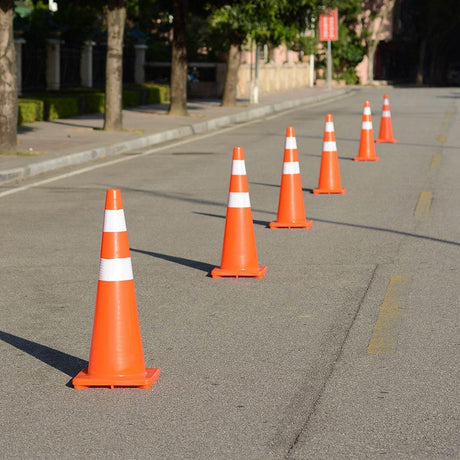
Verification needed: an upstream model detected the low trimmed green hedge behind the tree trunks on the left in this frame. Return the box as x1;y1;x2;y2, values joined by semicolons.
18;83;169;124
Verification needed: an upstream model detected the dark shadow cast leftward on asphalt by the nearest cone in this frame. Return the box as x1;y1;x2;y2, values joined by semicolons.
0;331;88;387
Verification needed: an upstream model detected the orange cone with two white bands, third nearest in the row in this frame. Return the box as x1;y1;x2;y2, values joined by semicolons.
269;126;313;228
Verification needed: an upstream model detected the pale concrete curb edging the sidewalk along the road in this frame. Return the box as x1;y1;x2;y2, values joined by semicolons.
0;89;354;184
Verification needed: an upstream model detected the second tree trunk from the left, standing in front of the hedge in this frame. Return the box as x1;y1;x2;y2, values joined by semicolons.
104;0;126;131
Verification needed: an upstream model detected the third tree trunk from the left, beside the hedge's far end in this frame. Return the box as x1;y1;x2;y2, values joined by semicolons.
169;0;188;116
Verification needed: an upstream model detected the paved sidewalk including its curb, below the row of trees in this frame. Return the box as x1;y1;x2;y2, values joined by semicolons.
0;88;353;184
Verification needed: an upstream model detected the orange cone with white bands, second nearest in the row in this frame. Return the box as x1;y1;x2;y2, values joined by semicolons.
211;147;267;278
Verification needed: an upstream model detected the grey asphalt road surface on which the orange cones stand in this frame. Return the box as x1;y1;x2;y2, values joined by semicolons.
0;88;460;459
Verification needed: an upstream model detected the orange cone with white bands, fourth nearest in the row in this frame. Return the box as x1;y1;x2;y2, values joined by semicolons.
313;113;345;195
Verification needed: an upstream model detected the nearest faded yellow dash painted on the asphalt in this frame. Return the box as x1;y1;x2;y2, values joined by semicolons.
367;276;412;354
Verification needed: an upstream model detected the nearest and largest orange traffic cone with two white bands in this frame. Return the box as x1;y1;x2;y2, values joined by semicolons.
72;189;160;389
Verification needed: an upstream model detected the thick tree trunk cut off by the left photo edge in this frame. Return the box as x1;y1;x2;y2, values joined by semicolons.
0;0;18;153
